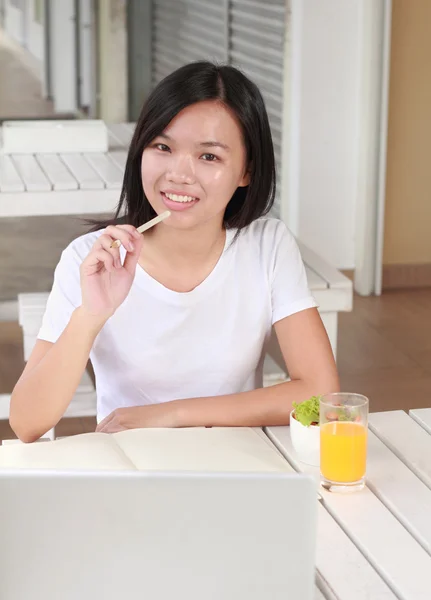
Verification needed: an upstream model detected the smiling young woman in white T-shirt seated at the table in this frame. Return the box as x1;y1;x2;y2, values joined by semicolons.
10;62;338;442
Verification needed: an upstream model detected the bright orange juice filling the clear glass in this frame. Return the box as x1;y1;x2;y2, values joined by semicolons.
320;421;367;483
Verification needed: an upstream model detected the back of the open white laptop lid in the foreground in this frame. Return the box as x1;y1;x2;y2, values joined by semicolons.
0;432;317;600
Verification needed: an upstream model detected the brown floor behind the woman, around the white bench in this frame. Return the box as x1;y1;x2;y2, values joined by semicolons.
0;289;431;439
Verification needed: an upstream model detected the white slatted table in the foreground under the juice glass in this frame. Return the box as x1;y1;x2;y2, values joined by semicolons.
267;408;431;600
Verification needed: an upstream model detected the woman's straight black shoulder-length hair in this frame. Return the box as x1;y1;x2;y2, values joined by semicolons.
93;61;275;229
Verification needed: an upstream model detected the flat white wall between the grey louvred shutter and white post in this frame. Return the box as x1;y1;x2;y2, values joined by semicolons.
283;0;362;269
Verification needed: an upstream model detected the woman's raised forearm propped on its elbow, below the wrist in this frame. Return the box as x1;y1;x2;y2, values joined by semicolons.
9;308;103;442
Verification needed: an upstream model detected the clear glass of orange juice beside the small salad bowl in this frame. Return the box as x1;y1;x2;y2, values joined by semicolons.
320;392;369;492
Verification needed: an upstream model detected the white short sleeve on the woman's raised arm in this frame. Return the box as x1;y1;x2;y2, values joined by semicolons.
37;243;82;343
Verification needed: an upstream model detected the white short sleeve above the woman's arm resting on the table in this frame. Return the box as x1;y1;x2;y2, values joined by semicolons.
271;221;317;324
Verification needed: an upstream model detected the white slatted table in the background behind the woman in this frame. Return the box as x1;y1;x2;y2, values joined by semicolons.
0;123;135;218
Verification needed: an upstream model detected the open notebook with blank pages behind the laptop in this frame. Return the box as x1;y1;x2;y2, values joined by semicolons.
0;427;289;473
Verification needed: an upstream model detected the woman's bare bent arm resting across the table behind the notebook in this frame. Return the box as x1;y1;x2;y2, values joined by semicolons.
97;308;339;433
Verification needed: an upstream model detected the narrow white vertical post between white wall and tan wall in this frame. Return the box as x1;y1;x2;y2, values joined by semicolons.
355;0;392;296
